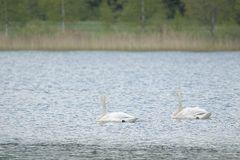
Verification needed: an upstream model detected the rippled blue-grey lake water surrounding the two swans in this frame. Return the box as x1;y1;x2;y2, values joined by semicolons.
0;52;240;159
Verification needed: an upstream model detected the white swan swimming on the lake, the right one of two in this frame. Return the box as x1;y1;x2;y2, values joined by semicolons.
171;92;211;119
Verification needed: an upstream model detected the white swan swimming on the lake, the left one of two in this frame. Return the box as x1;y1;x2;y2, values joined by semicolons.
97;96;137;123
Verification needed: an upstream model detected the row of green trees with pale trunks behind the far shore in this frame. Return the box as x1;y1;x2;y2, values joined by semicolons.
0;0;240;34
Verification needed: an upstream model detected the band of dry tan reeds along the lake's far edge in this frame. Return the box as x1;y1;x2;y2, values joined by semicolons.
0;32;240;51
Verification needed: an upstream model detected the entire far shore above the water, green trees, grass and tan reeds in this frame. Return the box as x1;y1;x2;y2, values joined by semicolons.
0;0;240;50
